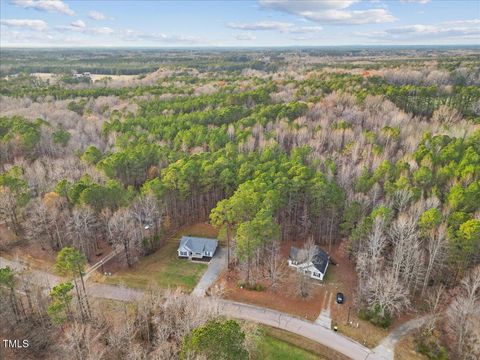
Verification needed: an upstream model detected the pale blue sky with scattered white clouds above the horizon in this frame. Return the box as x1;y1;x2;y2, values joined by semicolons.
0;0;480;47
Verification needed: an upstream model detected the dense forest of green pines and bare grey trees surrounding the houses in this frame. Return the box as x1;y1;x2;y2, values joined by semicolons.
0;49;480;359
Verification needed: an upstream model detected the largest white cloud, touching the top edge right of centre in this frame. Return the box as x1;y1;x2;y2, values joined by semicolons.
260;0;397;25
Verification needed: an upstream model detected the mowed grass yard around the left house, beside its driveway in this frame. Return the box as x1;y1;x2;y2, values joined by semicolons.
96;224;217;292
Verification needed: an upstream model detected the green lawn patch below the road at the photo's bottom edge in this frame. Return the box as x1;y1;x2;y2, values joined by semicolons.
259;335;319;360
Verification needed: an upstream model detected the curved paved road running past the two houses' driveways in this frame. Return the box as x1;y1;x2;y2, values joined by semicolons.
0;257;402;360
